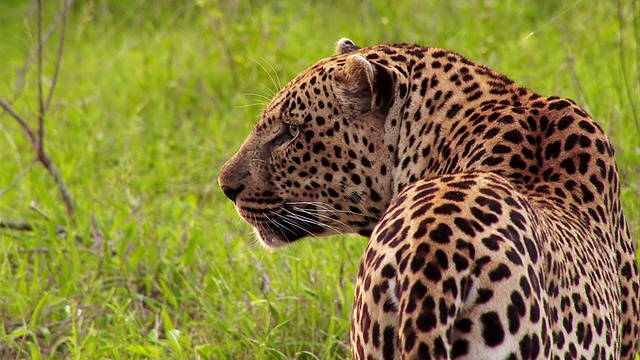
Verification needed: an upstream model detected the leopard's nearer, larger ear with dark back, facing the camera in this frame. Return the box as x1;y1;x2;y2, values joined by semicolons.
338;54;395;115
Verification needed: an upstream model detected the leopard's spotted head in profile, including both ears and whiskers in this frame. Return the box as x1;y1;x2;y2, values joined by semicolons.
218;39;397;248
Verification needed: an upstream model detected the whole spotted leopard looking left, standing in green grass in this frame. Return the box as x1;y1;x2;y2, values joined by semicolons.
218;38;640;360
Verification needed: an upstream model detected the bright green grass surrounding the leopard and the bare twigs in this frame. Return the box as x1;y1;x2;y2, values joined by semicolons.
0;0;640;359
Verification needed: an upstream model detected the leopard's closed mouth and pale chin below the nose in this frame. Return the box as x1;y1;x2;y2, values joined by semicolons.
238;203;326;248
